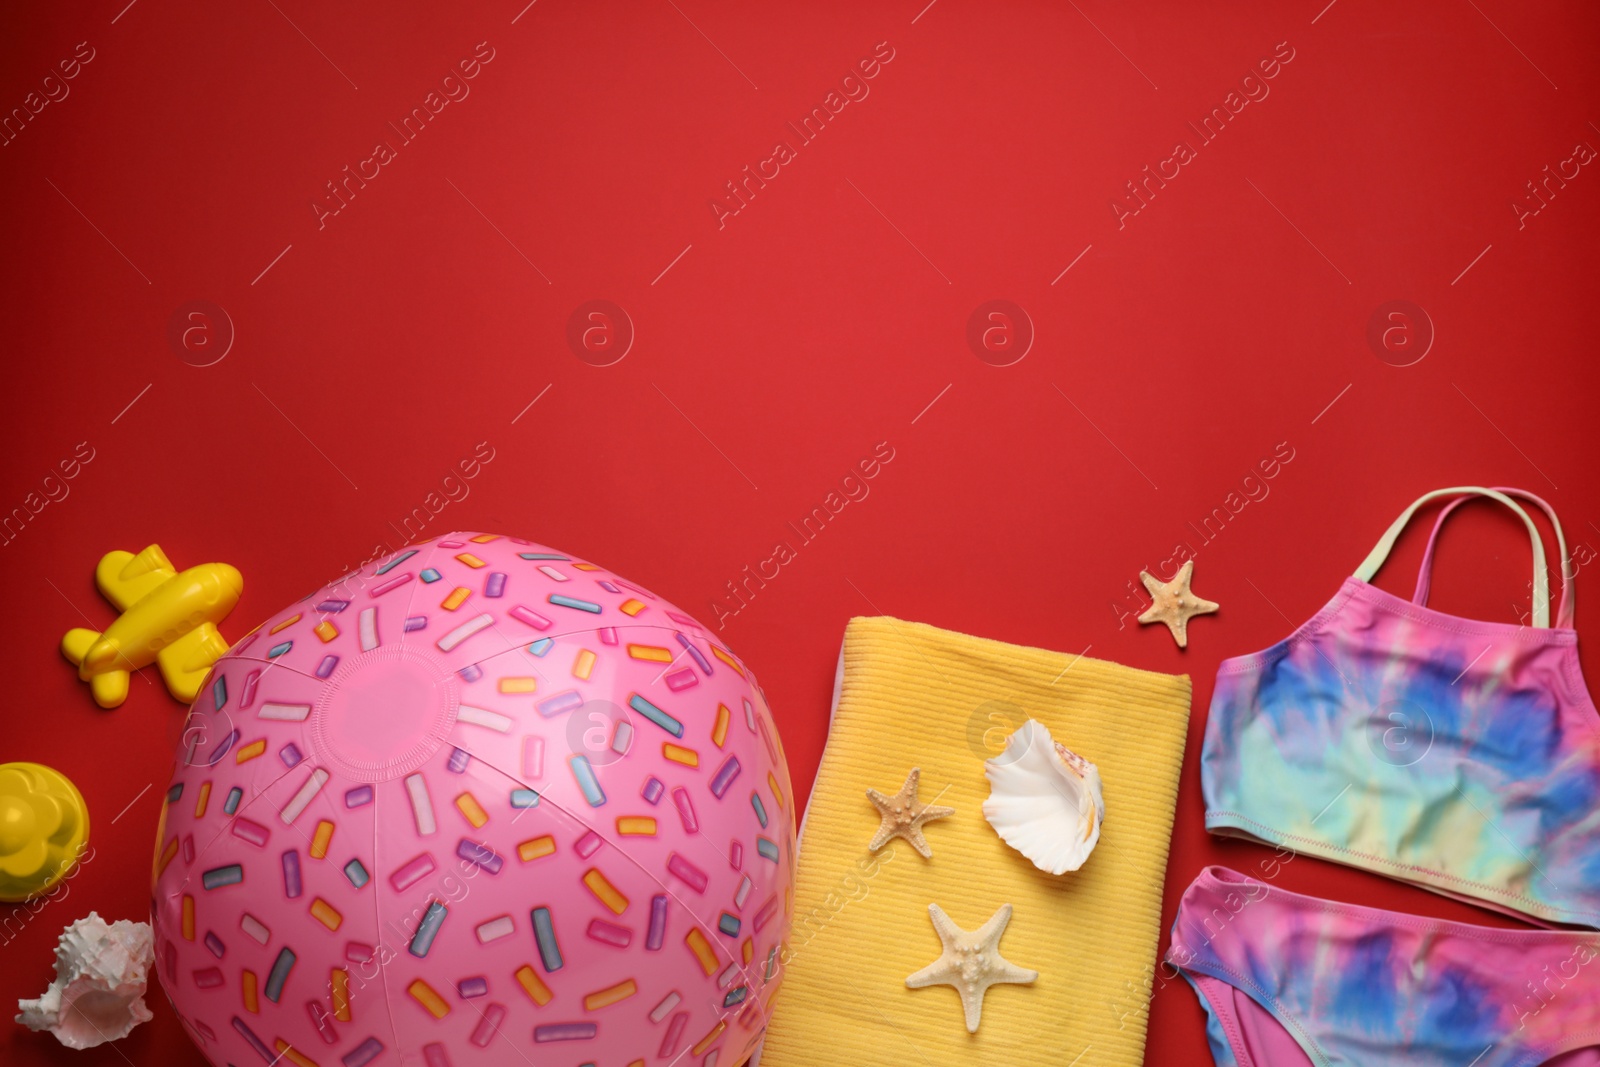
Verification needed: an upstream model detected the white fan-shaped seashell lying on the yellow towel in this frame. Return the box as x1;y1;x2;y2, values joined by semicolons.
984;718;1106;875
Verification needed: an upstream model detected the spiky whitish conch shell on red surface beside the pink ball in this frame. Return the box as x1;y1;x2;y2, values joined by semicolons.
16;912;155;1048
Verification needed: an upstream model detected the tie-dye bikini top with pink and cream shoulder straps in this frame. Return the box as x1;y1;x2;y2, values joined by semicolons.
1202;486;1600;928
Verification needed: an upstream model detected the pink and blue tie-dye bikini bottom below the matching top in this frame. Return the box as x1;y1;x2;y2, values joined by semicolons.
1166;867;1600;1067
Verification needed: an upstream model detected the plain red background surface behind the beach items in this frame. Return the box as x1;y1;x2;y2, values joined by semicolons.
0;0;1600;1064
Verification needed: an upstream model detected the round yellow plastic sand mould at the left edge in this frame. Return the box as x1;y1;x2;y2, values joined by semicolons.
0;763;90;902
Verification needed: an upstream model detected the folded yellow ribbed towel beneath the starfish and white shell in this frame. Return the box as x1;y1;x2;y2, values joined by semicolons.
762;617;1190;1067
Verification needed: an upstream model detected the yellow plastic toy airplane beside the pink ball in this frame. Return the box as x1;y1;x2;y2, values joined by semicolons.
61;544;245;707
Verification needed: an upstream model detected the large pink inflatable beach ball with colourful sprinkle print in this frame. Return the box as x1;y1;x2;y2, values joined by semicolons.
152;533;794;1067
